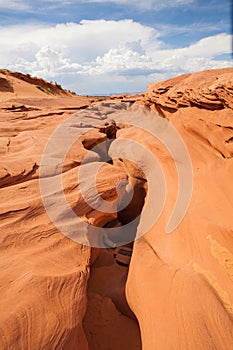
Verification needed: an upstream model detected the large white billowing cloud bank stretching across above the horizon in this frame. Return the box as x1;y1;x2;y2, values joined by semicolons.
0;20;231;94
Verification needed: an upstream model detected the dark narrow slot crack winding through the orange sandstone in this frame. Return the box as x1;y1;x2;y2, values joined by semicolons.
80;121;147;350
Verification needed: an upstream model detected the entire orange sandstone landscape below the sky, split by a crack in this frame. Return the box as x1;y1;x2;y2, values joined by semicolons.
0;69;233;350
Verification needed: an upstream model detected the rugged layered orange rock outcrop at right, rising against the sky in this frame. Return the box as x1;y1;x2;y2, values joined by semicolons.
144;68;233;112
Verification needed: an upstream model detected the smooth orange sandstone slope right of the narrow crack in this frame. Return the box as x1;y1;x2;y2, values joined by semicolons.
127;69;233;350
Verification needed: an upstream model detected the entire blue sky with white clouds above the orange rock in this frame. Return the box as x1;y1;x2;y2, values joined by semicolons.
0;0;233;95
